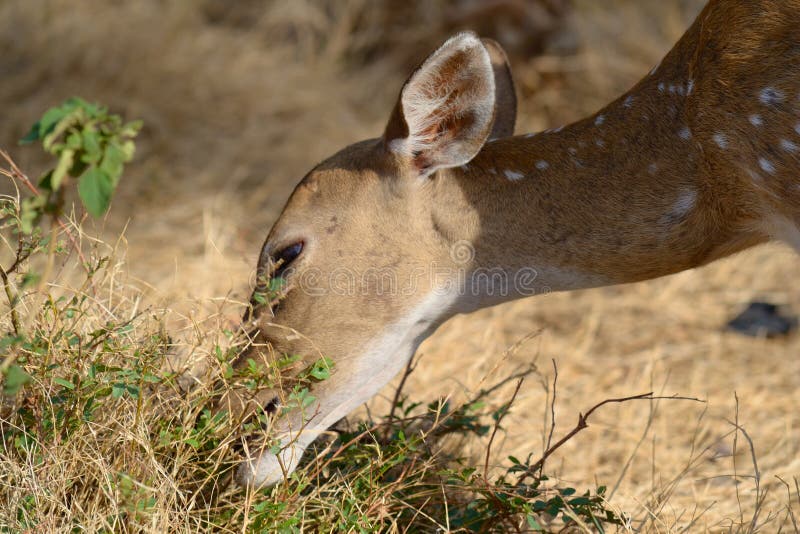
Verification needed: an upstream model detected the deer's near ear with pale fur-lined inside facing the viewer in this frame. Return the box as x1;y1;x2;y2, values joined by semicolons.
383;32;495;176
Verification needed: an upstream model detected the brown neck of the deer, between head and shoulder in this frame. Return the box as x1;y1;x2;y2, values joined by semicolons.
434;85;765;304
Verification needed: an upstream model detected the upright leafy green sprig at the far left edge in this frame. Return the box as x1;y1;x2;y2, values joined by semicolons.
0;98;141;396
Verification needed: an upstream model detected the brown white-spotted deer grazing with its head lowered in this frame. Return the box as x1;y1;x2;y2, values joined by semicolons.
226;0;800;485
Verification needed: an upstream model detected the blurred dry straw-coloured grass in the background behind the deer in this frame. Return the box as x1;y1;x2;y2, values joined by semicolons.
0;0;800;532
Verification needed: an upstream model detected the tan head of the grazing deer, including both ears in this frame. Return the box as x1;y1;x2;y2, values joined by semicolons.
227;33;516;485
